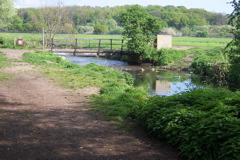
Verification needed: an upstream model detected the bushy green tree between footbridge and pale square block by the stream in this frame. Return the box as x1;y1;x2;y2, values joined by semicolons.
121;5;161;58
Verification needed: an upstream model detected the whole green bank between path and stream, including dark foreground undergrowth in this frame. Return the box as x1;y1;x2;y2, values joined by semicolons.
24;53;240;160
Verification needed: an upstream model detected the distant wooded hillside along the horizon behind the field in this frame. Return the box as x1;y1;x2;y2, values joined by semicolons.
7;5;229;37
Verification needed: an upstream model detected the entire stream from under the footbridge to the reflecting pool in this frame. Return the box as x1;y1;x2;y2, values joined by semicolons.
60;56;202;96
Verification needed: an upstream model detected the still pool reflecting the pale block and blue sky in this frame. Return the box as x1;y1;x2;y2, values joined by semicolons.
132;70;201;96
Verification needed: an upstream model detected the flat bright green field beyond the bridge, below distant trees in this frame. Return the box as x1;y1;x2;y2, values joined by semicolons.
0;33;231;48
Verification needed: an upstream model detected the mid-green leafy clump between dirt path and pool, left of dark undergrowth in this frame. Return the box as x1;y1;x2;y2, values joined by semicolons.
92;83;149;120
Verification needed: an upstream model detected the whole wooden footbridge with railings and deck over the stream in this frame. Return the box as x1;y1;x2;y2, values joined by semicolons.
50;38;127;57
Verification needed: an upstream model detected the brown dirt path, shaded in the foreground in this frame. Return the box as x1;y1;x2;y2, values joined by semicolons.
0;49;178;160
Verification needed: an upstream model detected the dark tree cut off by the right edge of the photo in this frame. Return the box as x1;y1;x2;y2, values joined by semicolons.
226;0;240;89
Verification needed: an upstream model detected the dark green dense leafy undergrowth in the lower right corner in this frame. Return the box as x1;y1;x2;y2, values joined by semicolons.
135;89;240;160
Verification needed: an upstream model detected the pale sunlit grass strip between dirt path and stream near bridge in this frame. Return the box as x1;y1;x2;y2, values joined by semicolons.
23;52;133;89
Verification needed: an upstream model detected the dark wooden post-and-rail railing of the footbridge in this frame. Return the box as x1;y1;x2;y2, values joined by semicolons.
51;38;127;52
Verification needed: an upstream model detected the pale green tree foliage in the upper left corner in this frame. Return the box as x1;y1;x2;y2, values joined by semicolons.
0;0;16;28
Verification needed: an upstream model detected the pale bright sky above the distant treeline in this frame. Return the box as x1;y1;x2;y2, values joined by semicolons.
15;0;233;14
